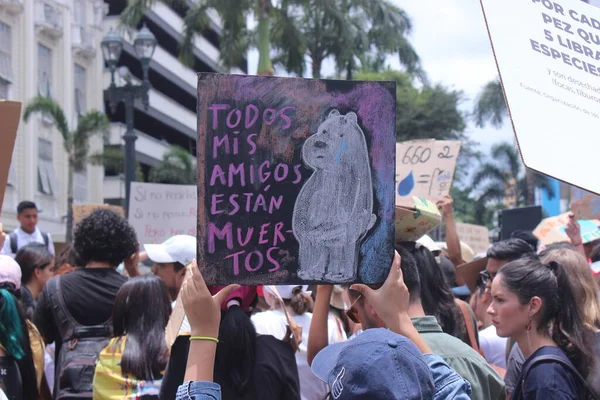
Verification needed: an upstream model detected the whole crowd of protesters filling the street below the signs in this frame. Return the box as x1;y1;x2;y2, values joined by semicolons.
0;197;600;400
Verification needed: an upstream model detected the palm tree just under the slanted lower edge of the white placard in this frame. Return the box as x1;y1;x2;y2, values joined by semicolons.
471;143;556;223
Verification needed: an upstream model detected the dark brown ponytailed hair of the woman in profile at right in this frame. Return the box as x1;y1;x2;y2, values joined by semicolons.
498;257;595;376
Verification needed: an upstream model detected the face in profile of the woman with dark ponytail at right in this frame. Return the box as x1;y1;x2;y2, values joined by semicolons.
487;274;530;338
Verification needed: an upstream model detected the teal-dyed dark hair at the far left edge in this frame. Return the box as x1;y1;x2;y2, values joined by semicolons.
0;289;25;360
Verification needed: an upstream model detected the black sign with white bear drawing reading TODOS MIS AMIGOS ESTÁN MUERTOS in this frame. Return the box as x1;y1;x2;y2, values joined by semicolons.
198;73;396;285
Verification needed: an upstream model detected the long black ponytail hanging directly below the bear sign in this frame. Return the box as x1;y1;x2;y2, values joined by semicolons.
215;305;256;399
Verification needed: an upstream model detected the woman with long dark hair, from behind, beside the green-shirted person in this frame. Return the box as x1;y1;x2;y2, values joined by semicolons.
401;242;477;347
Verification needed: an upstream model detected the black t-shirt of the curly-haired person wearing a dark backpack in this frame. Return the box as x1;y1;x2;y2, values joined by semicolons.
33;268;127;360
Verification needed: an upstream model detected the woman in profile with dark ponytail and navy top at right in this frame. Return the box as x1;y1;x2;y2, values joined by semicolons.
488;257;594;400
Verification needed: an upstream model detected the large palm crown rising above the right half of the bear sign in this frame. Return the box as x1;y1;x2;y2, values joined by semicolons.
272;0;424;79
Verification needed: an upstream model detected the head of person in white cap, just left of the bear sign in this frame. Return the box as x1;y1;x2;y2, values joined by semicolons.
144;235;196;301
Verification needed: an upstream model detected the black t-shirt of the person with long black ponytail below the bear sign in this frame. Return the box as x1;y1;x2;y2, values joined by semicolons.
160;335;300;400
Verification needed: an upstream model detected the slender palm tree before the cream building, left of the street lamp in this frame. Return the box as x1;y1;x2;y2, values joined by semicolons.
23;97;110;243
